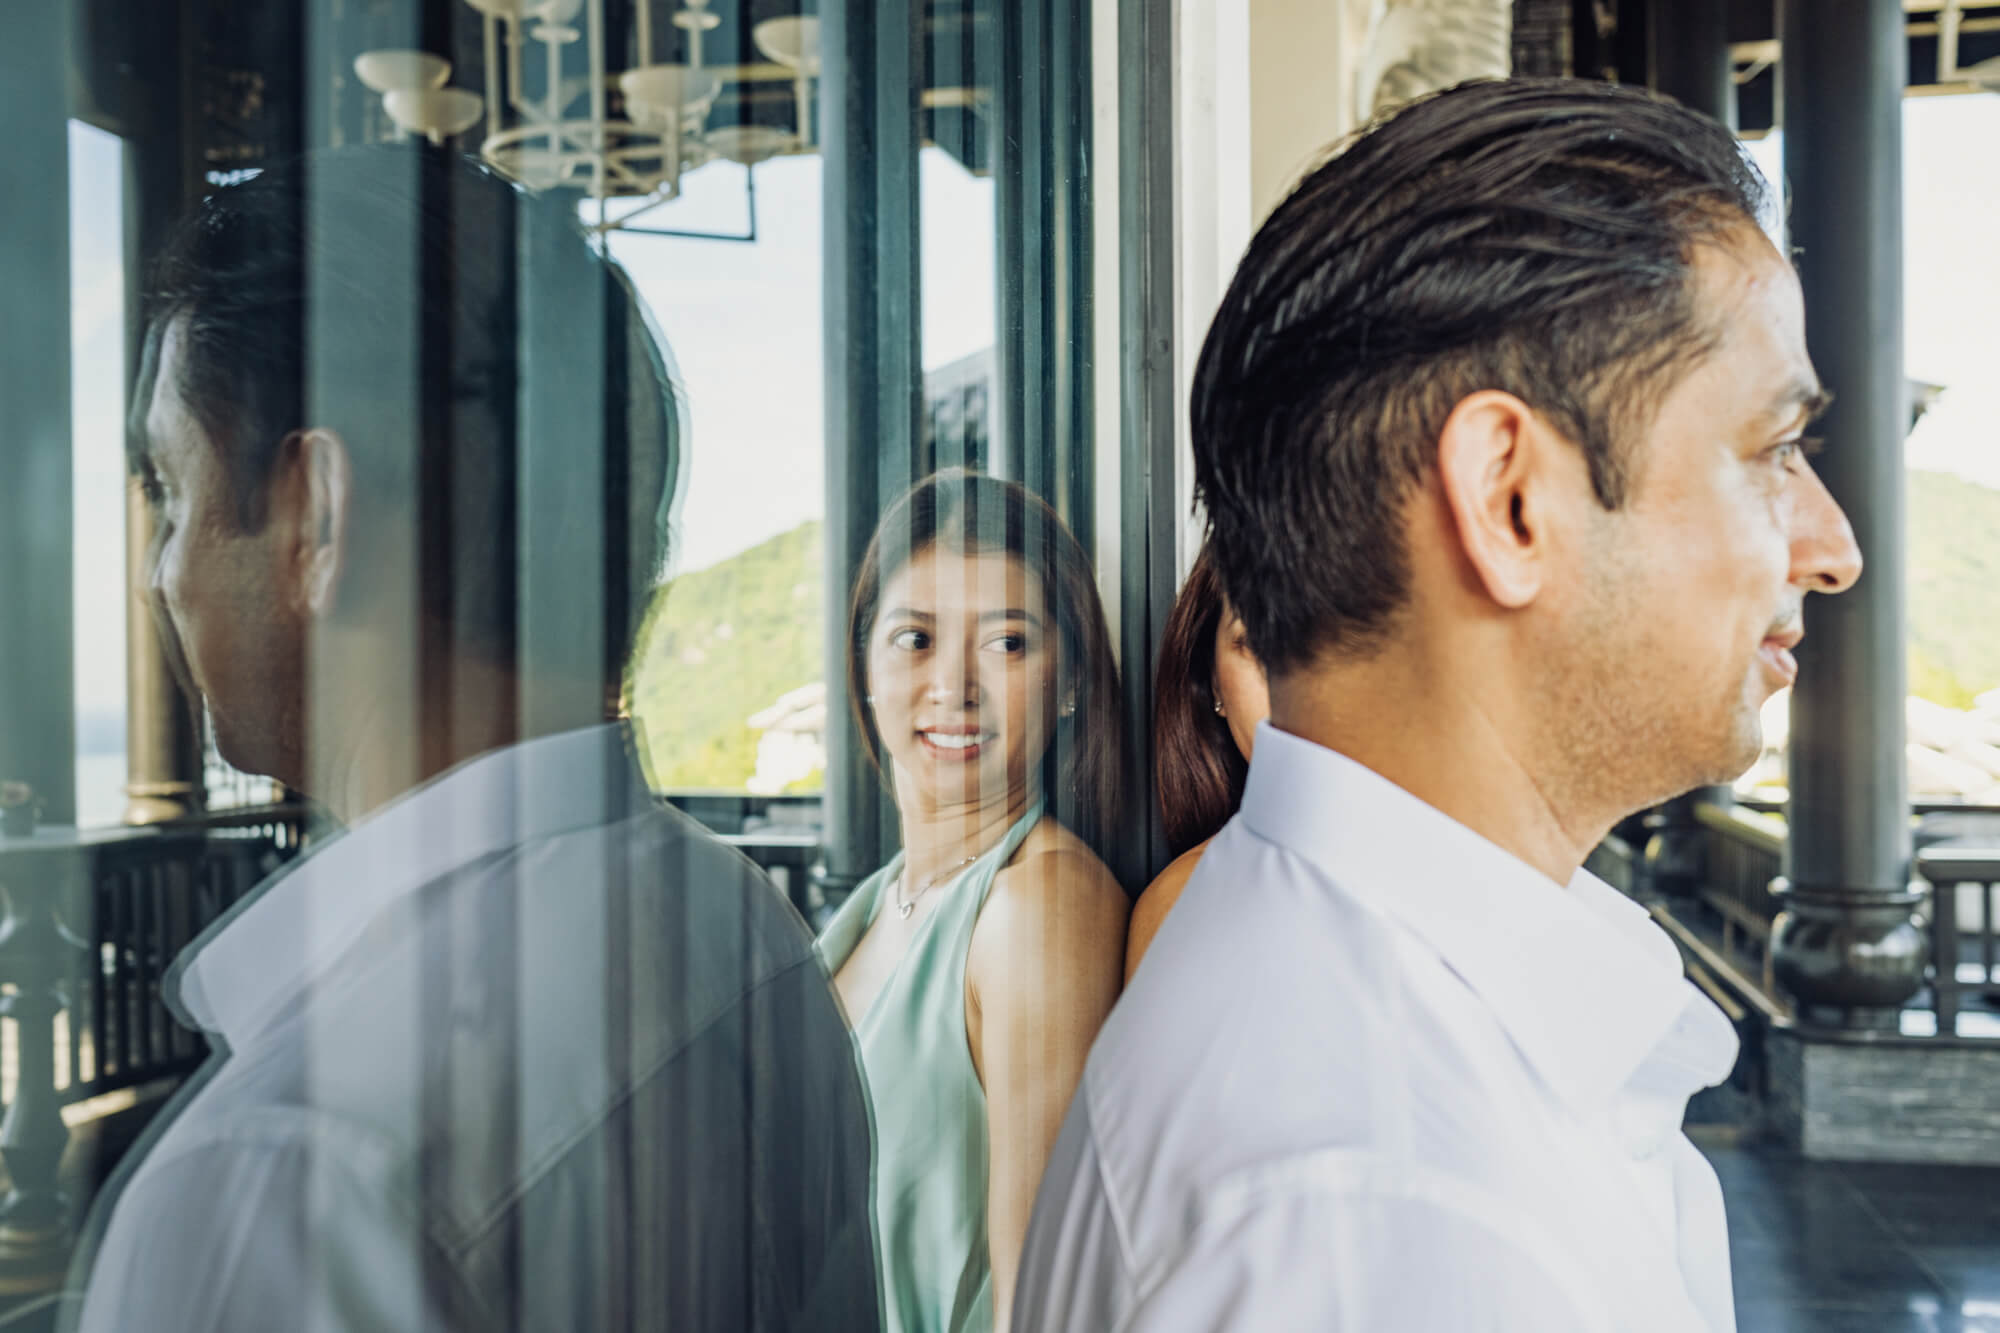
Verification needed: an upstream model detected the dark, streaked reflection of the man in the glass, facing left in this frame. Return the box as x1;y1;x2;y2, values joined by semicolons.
72;148;876;1333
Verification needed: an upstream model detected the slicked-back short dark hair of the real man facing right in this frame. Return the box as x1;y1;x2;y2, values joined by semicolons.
1192;80;1770;675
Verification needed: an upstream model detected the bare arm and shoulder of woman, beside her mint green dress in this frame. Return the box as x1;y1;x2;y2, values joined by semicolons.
966;849;1128;1331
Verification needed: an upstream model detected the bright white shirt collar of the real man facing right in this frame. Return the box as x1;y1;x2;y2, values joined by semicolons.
1242;723;1736;1111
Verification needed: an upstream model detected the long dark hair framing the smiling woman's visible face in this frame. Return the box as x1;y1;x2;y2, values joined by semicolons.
848;468;1124;863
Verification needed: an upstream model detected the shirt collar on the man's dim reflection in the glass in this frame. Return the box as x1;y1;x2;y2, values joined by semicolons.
162;723;656;1043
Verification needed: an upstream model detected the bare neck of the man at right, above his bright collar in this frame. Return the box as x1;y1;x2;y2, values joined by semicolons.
1270;654;1614;885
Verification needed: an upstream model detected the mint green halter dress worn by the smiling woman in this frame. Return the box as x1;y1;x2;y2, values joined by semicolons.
820;803;1042;1333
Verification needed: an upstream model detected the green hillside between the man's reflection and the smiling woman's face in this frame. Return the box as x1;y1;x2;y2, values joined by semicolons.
632;522;824;787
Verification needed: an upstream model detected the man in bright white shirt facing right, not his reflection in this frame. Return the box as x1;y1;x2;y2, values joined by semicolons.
1014;80;1860;1333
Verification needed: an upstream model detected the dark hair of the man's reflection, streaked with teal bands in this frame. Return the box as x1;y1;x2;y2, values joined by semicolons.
134;144;682;673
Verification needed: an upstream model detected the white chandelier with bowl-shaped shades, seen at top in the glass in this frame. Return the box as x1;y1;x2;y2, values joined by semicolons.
354;0;820;230
